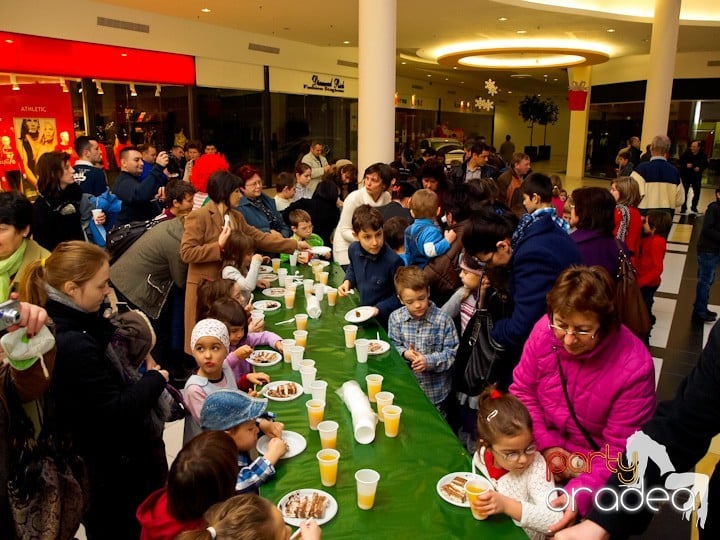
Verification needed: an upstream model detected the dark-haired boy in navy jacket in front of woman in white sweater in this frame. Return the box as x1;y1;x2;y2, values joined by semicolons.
338;204;403;328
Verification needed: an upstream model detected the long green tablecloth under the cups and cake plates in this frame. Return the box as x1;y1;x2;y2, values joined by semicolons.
255;264;527;540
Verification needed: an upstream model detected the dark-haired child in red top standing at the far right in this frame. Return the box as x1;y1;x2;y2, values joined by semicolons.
636;210;672;324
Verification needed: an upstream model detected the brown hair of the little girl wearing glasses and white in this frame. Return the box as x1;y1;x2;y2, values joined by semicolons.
478;385;532;448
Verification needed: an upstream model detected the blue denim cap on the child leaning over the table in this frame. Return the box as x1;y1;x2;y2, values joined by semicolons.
200;390;267;431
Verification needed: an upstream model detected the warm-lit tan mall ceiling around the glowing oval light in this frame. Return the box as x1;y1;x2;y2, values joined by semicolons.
97;0;720;99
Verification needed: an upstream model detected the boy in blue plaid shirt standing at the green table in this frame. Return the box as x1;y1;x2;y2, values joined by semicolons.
388;266;459;415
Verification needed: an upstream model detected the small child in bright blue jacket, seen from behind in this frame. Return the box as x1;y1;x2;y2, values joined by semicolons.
403;189;456;269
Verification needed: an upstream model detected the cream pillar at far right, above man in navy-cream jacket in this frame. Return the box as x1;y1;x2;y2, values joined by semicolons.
641;0;681;148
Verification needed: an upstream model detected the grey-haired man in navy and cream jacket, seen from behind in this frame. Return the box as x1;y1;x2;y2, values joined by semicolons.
636;135;685;216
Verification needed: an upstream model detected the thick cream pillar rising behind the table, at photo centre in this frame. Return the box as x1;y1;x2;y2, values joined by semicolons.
358;0;397;171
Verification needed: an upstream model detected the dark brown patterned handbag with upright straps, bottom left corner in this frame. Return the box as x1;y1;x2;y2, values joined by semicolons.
4;372;90;540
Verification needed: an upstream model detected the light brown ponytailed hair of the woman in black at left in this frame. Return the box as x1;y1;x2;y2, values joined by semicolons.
18;240;109;306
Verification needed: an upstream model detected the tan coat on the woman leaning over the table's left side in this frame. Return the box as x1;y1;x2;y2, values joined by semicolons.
180;201;297;354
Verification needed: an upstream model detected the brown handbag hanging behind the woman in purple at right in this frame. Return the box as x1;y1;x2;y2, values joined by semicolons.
615;239;652;341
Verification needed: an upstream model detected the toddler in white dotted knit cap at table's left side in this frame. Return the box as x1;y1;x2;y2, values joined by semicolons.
183;319;237;444
